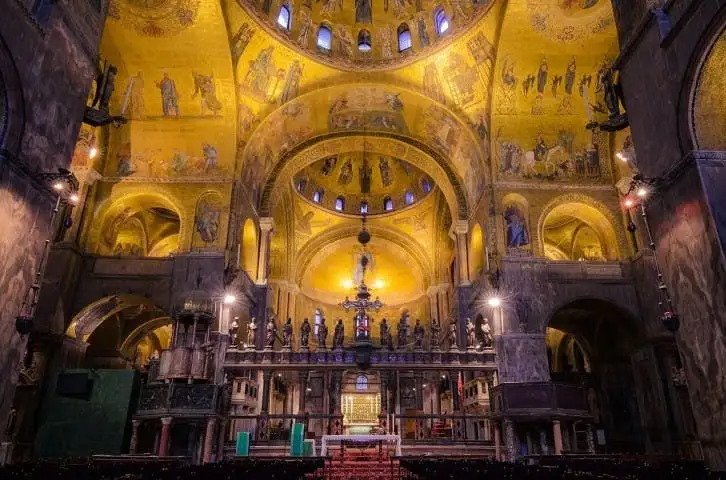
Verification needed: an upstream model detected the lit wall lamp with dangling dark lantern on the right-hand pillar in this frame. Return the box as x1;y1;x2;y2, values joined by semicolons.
623;175;681;333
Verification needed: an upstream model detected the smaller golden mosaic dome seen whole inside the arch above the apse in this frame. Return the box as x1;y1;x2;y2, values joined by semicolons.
293;151;434;215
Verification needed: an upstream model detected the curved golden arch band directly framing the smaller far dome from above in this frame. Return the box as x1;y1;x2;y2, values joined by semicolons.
260;131;469;220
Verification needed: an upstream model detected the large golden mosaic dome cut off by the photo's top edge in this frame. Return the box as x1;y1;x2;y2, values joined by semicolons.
239;0;500;70
